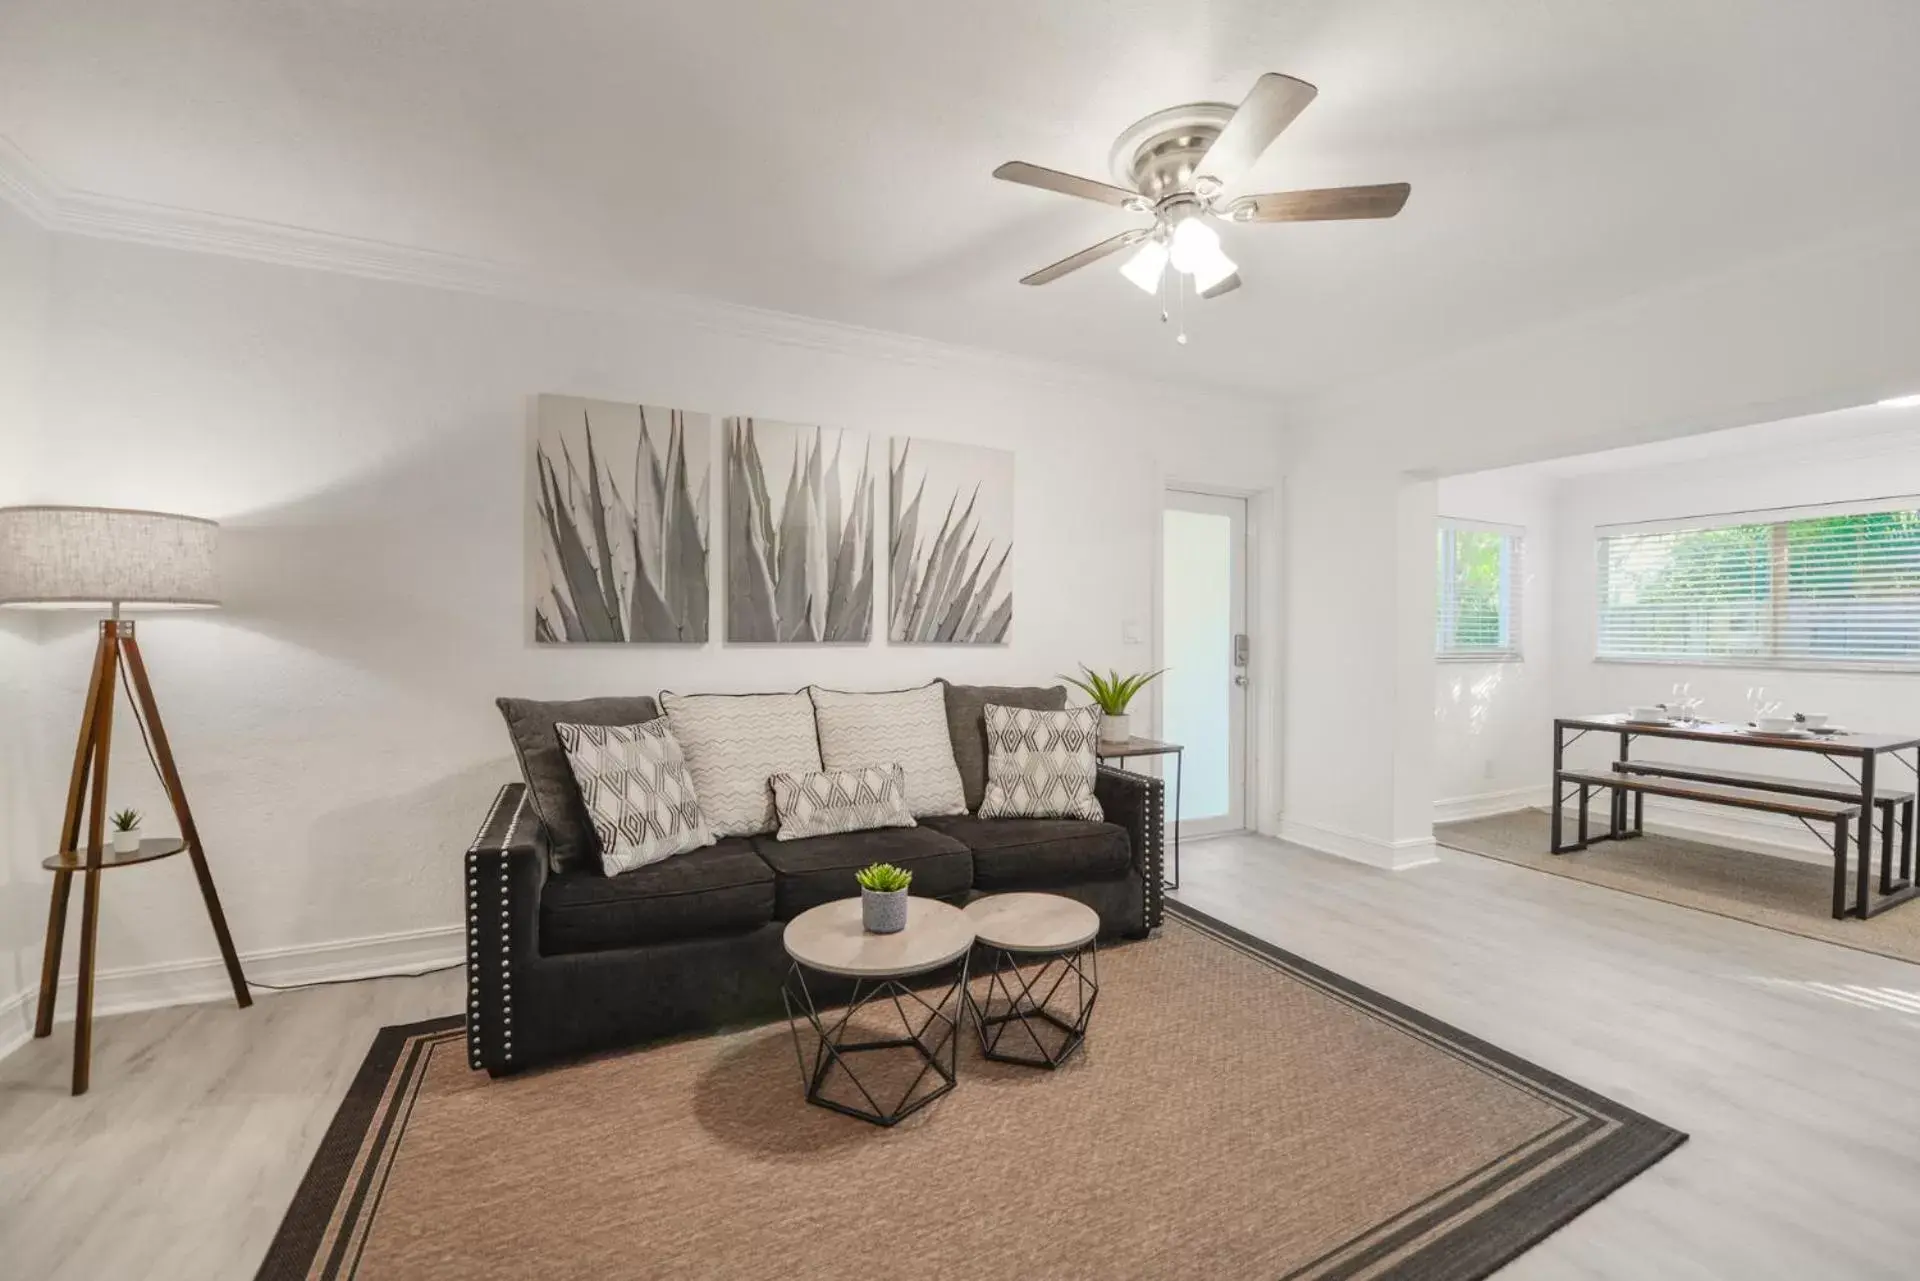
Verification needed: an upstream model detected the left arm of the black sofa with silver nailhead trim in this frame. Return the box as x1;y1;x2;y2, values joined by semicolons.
467;784;547;1076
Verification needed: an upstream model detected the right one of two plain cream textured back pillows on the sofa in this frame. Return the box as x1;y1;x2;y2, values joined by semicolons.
806;682;966;818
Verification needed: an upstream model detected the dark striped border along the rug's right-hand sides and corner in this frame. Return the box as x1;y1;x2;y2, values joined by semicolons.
1165;899;1688;1281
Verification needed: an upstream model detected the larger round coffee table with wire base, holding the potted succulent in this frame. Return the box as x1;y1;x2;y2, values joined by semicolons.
781;899;973;1125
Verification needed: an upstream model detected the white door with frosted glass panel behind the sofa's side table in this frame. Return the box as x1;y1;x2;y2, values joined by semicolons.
1160;492;1250;835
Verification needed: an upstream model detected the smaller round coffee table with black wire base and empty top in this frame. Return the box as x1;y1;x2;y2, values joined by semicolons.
966;893;1100;1068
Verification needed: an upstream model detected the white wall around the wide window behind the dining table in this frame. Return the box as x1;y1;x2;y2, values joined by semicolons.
1540;409;1920;862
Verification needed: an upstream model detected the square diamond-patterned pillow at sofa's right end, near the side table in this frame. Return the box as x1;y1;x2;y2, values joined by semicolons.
979;703;1106;822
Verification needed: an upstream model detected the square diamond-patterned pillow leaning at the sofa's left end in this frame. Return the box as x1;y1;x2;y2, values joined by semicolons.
553;716;714;876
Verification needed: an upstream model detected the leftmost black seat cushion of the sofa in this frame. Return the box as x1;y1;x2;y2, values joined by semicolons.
540;837;774;956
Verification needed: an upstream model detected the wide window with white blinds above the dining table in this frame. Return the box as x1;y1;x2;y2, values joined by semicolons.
1596;499;1920;666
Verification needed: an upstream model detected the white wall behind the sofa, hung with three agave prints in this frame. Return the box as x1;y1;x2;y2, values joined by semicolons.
11;236;1281;1001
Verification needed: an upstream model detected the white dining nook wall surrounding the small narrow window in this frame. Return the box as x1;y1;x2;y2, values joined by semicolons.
1432;469;1557;822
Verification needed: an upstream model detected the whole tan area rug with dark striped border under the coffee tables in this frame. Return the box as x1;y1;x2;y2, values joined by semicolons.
259;905;1686;1281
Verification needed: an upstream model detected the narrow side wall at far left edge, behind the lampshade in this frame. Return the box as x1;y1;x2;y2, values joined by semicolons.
0;202;50;1054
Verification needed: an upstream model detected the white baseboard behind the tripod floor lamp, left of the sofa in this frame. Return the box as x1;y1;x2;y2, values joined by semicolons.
0;926;467;1058
